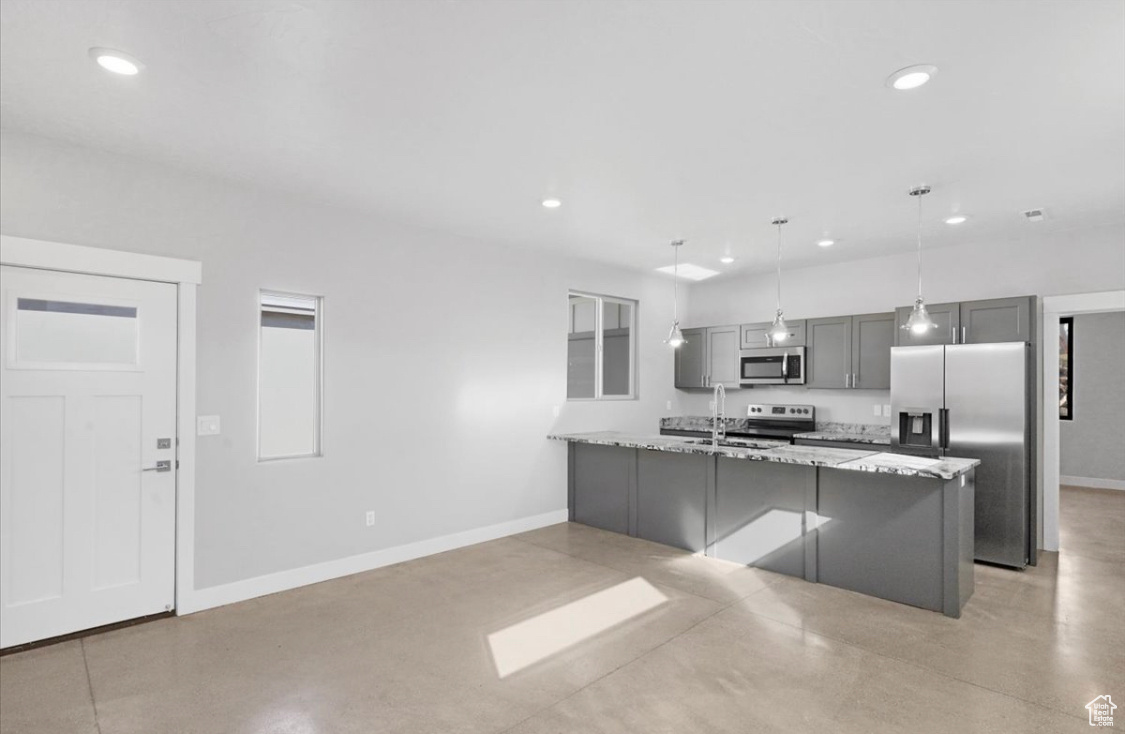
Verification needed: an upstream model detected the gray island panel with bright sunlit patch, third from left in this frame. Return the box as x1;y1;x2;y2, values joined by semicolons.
712;457;816;578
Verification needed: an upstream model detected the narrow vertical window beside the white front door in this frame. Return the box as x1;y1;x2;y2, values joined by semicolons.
258;290;322;460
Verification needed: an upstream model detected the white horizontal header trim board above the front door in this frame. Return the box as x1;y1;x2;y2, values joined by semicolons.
0;234;203;285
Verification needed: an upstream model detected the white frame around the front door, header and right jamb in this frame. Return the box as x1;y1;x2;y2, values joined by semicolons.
0;234;203;615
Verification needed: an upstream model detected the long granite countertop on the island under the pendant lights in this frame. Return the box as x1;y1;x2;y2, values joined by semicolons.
548;431;980;480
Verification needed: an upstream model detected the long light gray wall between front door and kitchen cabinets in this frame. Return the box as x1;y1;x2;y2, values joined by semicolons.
0;132;683;589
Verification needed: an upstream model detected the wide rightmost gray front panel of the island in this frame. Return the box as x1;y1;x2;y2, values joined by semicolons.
817;468;945;611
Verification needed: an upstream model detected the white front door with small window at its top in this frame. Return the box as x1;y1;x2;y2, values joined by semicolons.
0;266;177;647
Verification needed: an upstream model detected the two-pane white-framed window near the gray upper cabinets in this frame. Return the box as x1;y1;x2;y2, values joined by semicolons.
566;293;637;400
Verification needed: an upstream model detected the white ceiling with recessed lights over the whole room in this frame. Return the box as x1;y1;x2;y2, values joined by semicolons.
0;0;1125;276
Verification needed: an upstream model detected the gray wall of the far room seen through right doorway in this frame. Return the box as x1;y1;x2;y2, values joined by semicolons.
1059;312;1125;482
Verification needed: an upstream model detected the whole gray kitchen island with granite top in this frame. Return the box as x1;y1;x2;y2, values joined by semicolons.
550;431;980;617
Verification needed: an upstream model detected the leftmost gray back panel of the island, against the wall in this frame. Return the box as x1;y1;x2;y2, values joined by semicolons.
569;444;637;534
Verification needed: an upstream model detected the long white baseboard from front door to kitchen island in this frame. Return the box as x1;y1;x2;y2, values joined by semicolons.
176;510;567;615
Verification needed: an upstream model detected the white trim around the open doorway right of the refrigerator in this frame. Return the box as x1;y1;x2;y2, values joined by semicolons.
1042;290;1125;551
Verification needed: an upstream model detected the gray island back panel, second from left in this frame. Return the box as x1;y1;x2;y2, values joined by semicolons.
636;450;713;553
